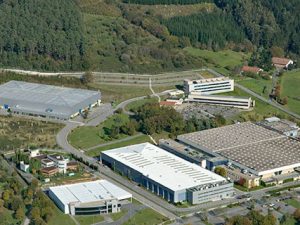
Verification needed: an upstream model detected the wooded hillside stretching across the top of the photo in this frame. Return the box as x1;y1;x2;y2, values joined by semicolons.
0;0;300;73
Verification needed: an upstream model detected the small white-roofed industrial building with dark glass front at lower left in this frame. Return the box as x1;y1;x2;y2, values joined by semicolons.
48;180;132;215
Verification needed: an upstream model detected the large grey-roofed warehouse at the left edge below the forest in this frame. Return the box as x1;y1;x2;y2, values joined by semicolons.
0;81;101;120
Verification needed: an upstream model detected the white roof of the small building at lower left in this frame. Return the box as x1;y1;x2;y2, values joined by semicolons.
49;180;132;204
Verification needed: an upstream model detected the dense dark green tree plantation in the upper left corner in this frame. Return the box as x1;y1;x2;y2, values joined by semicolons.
0;0;84;70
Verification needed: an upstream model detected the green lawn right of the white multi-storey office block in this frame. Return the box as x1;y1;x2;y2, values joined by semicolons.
238;78;272;99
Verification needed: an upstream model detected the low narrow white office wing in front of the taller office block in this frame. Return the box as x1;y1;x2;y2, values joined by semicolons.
186;92;255;109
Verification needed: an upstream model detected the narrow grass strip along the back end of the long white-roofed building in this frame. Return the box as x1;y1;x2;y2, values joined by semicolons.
86;135;152;157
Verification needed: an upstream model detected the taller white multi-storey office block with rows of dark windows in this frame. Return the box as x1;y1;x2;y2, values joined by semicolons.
183;77;234;95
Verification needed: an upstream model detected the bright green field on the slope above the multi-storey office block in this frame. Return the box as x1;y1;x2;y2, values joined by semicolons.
185;47;250;75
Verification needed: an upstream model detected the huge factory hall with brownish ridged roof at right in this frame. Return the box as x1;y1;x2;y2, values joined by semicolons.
177;122;300;178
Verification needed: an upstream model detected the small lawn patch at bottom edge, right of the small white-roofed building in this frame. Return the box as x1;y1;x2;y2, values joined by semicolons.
123;208;168;225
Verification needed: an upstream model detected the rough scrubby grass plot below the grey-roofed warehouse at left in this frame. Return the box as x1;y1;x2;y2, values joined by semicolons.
0;116;63;150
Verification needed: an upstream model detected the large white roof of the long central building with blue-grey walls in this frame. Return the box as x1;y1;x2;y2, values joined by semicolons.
102;143;225;191
